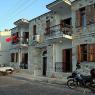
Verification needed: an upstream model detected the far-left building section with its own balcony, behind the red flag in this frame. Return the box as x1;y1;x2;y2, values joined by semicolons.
10;19;29;69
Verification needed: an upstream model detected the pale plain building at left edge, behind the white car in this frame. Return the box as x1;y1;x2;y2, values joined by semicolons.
0;30;11;66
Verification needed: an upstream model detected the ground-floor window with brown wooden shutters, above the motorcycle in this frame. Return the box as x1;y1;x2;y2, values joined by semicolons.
77;44;95;63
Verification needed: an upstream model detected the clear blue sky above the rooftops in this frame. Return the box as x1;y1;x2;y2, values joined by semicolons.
0;0;74;31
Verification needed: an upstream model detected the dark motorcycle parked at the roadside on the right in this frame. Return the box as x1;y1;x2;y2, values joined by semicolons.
67;66;95;88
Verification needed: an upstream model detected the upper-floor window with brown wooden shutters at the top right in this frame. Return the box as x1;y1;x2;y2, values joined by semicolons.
76;4;95;27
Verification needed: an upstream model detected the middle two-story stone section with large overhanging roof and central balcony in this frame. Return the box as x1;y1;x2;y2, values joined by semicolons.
28;0;72;77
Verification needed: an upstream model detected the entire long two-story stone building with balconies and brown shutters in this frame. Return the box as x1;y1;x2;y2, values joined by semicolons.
11;0;95;78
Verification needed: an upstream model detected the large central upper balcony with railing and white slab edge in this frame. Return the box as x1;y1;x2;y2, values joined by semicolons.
44;24;72;40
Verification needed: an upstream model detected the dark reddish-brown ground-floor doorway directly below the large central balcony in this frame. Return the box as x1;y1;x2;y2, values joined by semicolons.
63;49;72;72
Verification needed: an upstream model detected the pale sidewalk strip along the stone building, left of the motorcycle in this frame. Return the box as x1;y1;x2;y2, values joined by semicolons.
13;72;67;85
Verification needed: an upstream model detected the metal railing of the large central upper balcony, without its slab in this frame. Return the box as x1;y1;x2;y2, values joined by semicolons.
44;24;72;36
